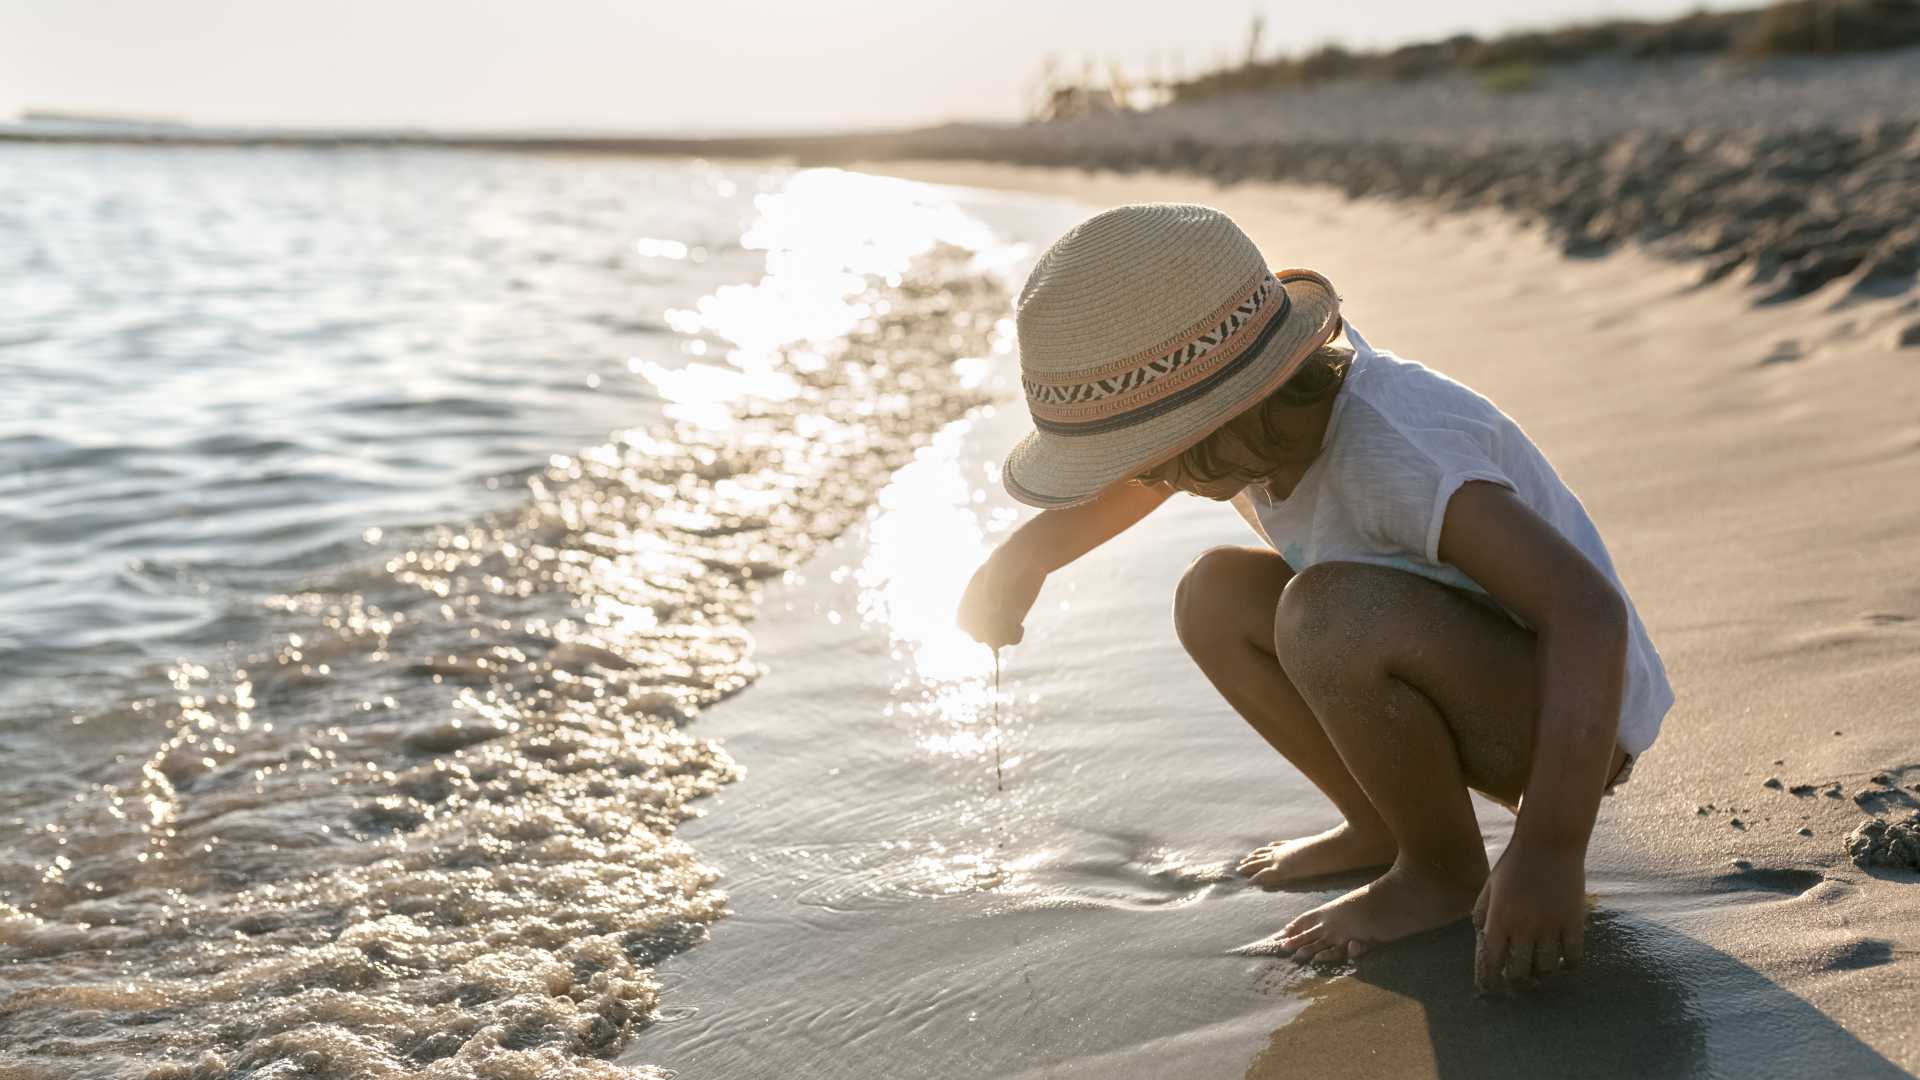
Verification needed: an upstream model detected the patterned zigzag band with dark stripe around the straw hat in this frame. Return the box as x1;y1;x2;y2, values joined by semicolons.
1021;269;1290;434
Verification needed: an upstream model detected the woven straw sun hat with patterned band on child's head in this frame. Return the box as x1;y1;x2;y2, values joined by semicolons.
1000;202;1340;507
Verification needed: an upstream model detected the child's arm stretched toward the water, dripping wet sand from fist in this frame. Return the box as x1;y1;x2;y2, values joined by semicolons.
960;484;1173;648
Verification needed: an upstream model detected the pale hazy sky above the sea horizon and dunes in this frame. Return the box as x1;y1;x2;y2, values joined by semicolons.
0;0;1751;133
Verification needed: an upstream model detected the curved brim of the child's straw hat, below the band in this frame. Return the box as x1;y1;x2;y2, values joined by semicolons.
1000;271;1340;509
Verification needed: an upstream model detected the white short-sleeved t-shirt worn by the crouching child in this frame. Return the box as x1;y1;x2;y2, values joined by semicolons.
1233;323;1674;755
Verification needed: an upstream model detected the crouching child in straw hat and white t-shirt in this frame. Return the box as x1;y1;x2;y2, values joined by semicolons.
960;204;1672;986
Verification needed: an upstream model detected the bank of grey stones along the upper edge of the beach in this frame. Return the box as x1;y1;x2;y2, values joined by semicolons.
893;50;1920;300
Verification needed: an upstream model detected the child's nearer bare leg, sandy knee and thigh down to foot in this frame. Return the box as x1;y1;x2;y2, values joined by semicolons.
1273;563;1538;963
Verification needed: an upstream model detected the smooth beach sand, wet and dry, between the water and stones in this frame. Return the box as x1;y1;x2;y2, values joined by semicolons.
624;161;1920;1078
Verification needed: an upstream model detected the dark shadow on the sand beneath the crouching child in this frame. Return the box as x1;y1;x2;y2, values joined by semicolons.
1246;911;1908;1080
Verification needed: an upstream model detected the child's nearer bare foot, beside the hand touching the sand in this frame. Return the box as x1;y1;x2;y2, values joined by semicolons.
1279;863;1486;963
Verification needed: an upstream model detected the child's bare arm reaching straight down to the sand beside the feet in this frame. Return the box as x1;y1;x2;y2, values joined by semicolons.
1440;480;1628;986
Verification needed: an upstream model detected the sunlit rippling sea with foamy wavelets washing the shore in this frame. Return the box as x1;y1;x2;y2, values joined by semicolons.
0;148;1090;1078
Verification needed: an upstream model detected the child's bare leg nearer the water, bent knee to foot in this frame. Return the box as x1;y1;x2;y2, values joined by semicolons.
1173;548;1396;886
